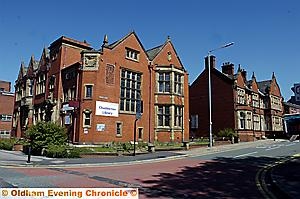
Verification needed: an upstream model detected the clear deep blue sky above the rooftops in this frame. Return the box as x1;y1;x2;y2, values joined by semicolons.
0;0;300;100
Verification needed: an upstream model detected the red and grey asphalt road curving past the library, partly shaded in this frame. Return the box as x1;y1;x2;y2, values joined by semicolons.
0;141;300;198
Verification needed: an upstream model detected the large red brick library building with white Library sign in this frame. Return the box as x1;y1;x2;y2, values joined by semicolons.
14;32;189;143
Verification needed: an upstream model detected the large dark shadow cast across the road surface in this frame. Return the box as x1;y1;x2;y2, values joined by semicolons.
138;157;280;199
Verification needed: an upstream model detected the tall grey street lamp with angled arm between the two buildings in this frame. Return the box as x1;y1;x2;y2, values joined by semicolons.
207;42;234;148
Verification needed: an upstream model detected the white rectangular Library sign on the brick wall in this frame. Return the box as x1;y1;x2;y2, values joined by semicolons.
96;101;119;117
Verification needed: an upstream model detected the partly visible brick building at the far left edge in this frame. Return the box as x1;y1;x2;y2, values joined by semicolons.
0;80;14;139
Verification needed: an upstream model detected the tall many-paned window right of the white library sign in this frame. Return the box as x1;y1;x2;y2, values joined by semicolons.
120;69;142;112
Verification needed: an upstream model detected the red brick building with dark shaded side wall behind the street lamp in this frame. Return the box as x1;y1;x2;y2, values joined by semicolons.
189;56;283;141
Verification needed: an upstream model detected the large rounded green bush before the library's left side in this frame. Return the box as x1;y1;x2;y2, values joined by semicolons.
25;121;67;154
